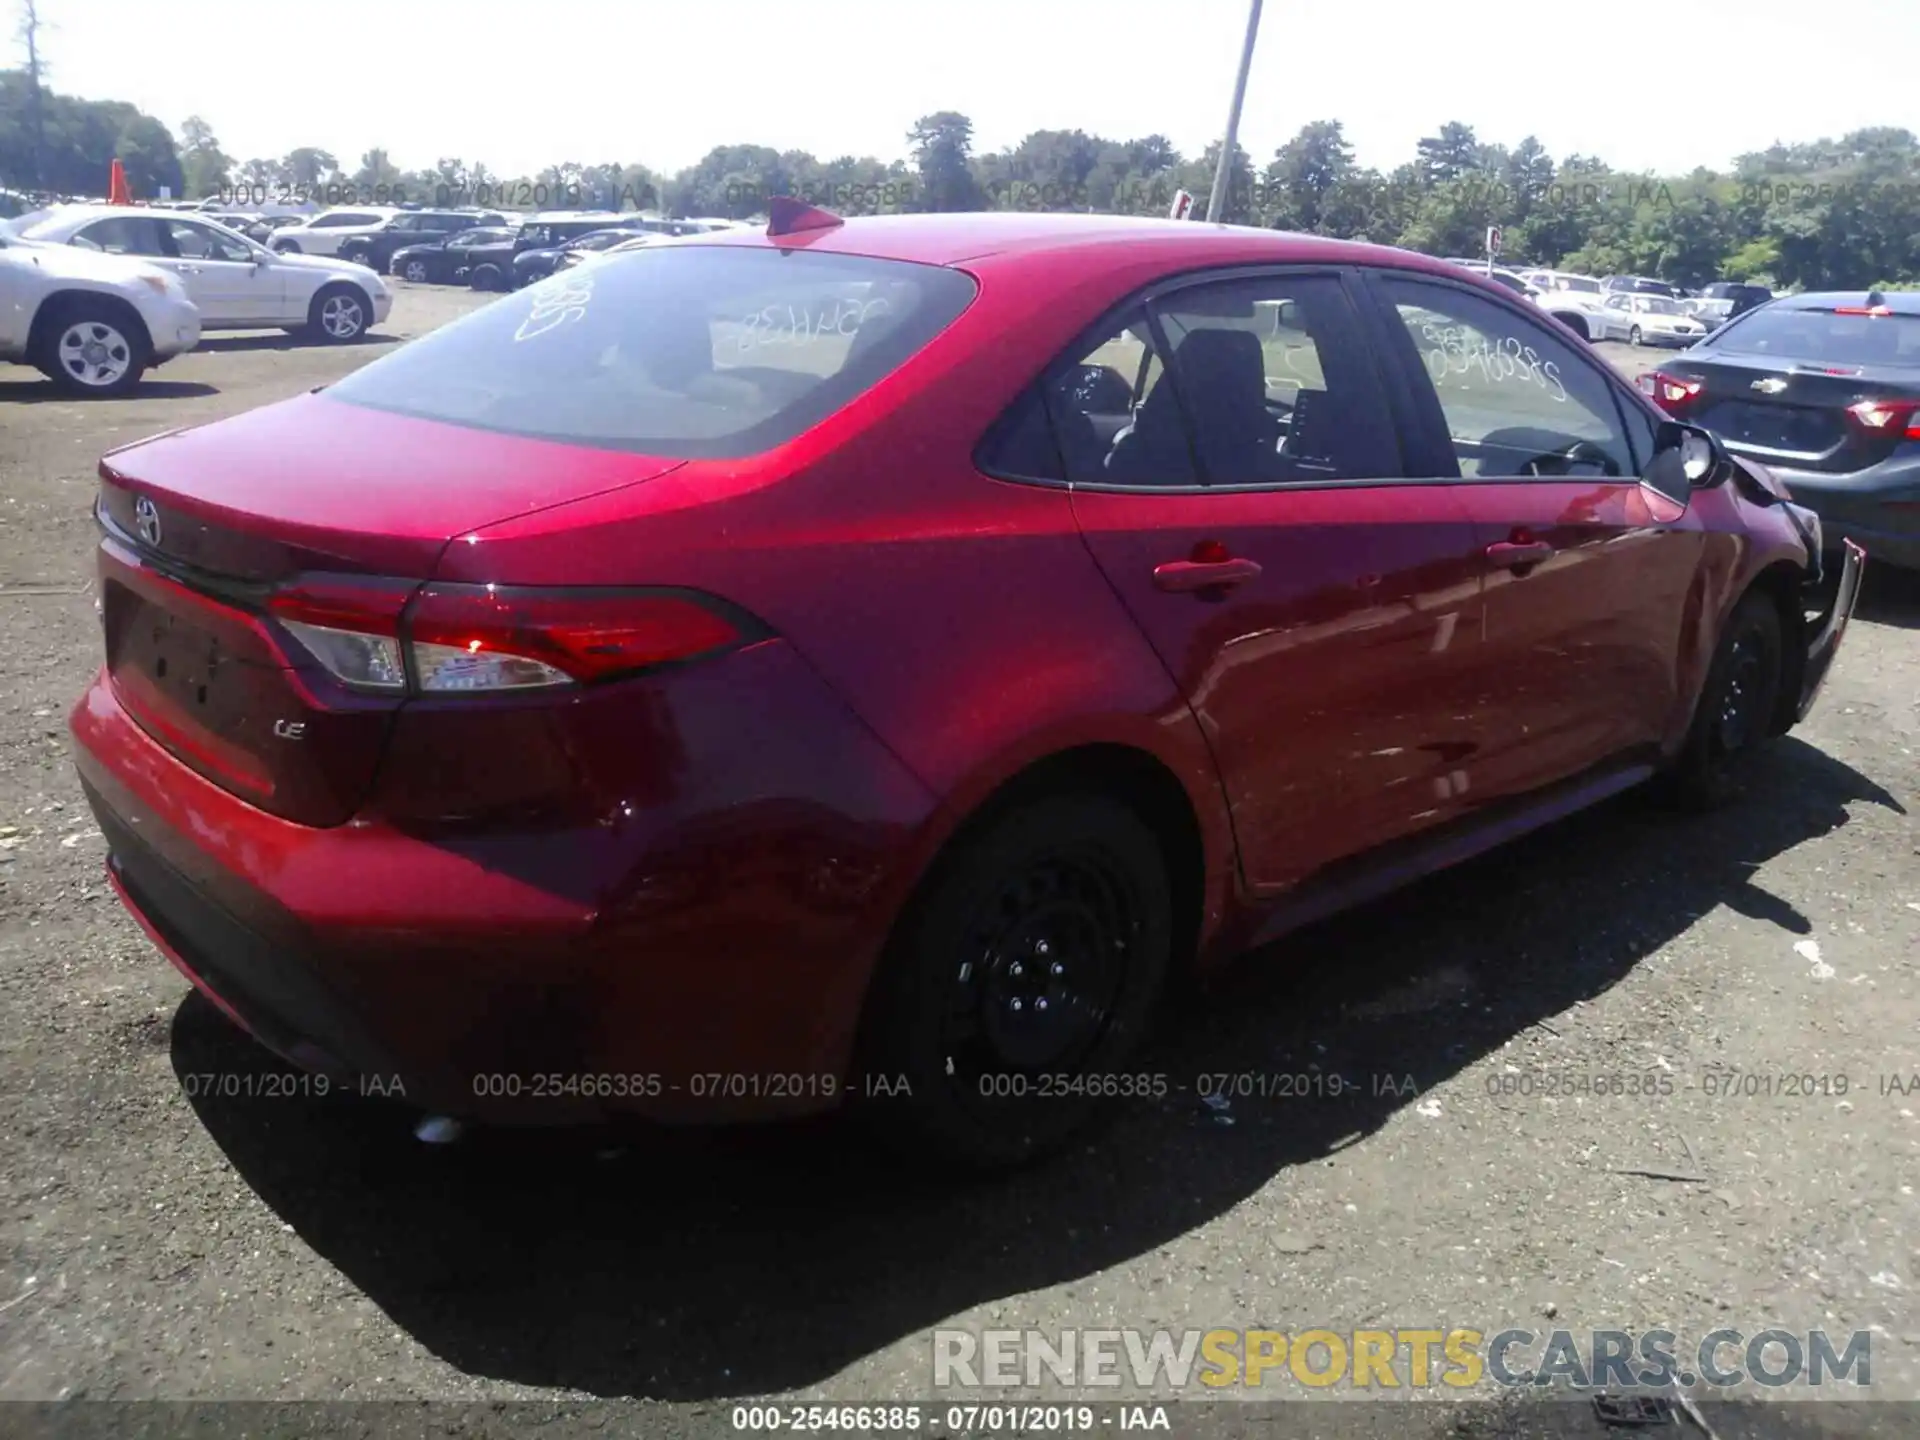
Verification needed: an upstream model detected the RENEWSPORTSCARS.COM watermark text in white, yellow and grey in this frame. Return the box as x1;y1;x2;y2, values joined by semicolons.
933;1329;1874;1394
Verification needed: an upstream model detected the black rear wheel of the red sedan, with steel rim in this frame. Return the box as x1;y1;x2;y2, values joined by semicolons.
854;795;1173;1169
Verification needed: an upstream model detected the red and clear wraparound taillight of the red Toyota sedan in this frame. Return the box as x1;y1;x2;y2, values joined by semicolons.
269;586;755;695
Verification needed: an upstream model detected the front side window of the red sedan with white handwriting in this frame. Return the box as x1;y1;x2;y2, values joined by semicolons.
1382;276;1636;478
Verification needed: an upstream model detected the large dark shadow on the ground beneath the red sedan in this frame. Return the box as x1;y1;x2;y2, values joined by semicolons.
173;739;1901;1400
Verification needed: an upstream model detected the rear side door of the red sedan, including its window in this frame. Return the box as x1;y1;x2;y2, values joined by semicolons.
1046;269;1480;891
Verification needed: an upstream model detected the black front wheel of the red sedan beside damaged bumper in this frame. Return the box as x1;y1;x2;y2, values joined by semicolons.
1668;593;1786;810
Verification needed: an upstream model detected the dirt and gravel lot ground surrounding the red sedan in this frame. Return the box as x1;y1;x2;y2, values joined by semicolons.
0;288;1920;1436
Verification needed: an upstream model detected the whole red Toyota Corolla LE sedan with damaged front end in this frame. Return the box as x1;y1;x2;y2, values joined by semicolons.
71;202;1862;1164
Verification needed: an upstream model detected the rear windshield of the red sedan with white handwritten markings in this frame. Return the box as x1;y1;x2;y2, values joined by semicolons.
326;246;973;459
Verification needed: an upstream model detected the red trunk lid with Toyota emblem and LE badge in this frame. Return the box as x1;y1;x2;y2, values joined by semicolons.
98;396;680;826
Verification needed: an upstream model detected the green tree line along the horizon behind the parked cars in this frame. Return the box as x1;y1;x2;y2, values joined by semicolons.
0;71;1920;288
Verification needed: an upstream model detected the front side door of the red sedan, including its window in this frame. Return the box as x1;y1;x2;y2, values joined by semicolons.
1371;271;1705;814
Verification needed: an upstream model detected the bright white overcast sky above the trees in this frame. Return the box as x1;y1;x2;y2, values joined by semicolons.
30;0;1920;175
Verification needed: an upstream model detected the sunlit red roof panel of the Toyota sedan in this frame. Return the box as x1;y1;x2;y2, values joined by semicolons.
676;211;1473;276
